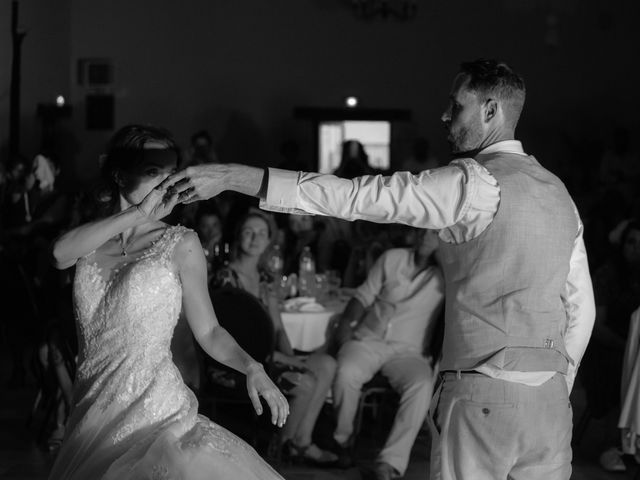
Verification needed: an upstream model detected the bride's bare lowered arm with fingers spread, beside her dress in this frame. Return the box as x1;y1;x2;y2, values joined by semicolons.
174;232;289;427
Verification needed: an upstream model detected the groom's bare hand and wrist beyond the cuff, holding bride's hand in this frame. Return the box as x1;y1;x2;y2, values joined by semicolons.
161;163;264;203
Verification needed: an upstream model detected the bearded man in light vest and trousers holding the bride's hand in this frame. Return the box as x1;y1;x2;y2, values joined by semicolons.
166;60;595;480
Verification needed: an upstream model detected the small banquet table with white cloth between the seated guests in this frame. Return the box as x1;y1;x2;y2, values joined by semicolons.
280;298;346;352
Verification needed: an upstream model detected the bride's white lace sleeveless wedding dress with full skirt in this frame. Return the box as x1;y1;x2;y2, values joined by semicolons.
49;227;281;480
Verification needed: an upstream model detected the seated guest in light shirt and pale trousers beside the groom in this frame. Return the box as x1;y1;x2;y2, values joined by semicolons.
333;230;444;479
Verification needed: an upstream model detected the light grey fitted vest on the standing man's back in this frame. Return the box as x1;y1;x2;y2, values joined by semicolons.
440;153;578;373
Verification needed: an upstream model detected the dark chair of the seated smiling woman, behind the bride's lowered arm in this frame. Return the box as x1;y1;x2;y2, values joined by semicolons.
197;287;275;447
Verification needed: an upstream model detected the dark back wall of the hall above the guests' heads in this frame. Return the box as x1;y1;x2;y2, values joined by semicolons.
0;0;640;186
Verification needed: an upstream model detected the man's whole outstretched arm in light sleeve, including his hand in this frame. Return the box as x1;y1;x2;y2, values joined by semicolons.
166;161;477;229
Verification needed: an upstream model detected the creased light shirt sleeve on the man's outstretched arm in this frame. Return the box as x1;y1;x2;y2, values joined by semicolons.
260;161;477;229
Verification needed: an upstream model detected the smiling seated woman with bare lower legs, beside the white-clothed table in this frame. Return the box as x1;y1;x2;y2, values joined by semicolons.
212;212;338;465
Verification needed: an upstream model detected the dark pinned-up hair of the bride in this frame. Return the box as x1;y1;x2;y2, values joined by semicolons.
96;125;181;216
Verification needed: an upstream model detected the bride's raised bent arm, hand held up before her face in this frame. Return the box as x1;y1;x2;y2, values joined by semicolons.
53;187;179;270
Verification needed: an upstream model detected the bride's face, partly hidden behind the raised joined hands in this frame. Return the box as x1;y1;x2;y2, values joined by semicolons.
119;142;178;205
